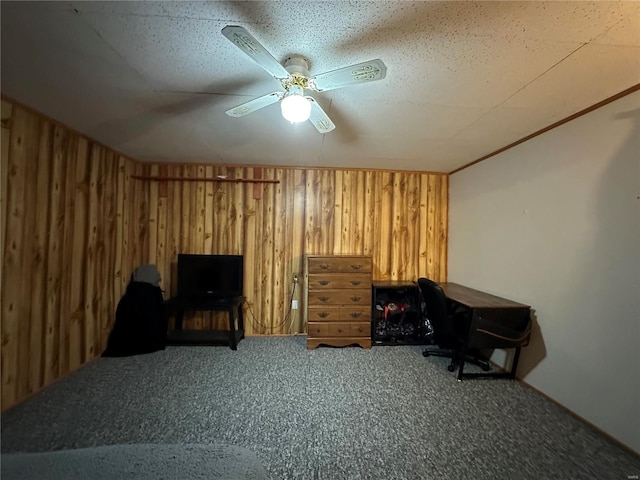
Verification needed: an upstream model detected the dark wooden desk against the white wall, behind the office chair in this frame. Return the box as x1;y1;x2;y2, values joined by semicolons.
440;283;531;380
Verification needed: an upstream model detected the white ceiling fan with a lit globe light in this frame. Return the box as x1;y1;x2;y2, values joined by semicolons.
222;25;387;133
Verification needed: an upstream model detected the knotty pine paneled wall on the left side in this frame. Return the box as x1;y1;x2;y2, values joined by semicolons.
0;100;138;410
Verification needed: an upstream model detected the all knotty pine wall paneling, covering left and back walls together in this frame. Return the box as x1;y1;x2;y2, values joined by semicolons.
0;100;448;410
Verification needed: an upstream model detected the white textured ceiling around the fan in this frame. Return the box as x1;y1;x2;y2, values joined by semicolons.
0;1;640;172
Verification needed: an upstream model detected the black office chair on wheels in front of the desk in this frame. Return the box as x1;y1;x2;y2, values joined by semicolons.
418;277;490;372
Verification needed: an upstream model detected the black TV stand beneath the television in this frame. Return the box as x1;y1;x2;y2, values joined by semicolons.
165;296;245;350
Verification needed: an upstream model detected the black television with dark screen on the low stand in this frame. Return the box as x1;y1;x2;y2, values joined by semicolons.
178;253;244;299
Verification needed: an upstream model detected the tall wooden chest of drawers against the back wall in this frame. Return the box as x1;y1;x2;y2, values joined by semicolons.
307;255;373;348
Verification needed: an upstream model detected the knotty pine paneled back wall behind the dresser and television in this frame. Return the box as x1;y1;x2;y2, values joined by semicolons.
134;165;448;335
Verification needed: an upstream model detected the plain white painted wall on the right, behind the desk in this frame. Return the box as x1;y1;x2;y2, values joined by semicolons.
448;92;640;453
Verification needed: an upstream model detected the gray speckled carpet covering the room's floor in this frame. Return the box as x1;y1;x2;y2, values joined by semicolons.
2;337;640;480
